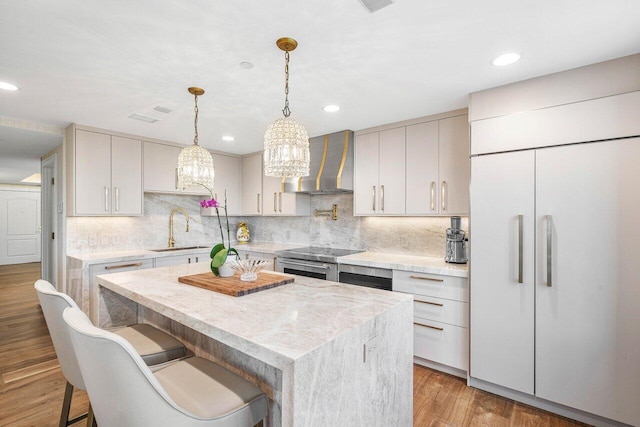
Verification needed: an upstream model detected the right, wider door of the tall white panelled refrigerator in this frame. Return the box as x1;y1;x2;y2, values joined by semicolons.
536;138;640;425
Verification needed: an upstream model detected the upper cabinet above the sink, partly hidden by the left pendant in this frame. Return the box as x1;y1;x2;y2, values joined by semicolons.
144;141;208;195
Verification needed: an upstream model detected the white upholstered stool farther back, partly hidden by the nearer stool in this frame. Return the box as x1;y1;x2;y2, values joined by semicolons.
34;280;186;427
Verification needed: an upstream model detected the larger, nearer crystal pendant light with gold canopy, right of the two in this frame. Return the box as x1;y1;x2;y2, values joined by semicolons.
264;37;309;178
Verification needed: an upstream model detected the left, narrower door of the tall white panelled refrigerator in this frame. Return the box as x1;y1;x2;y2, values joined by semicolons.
470;151;535;394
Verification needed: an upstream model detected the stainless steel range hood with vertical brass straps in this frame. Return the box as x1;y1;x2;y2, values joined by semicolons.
284;130;353;194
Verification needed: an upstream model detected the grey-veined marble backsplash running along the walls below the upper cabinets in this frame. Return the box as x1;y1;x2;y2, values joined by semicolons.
67;193;468;257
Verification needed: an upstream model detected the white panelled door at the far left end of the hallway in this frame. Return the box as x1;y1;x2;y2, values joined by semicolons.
0;191;42;265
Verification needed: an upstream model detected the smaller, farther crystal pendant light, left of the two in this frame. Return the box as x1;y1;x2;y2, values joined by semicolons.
178;87;214;189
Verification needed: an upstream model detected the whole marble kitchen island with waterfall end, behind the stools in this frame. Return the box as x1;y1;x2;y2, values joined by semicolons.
97;264;413;427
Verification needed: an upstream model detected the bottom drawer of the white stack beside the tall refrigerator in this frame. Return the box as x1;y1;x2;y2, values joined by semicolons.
413;320;469;371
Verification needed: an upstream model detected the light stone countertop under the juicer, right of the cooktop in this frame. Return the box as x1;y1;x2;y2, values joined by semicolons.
338;252;469;277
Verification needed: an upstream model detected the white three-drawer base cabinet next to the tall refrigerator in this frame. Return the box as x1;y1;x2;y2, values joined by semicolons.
392;270;469;376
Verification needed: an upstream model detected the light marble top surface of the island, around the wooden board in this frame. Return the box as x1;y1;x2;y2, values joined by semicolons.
97;263;413;369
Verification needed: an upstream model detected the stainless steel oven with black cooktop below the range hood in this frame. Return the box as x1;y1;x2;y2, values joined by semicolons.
275;246;361;282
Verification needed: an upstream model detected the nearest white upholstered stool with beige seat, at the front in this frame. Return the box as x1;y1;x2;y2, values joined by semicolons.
62;307;268;427
